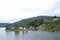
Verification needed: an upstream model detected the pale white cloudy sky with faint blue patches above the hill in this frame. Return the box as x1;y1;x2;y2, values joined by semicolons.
0;0;60;23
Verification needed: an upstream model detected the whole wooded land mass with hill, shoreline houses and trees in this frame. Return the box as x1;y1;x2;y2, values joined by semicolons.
6;16;60;31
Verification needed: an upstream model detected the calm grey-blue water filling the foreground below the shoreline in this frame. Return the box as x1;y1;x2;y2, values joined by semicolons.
0;28;60;40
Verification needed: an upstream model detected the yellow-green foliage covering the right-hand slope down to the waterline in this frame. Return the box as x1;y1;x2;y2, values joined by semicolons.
42;19;60;31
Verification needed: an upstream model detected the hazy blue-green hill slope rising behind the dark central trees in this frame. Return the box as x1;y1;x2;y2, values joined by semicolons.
13;16;52;26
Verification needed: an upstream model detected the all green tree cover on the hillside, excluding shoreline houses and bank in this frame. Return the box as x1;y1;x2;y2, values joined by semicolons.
6;16;60;30
